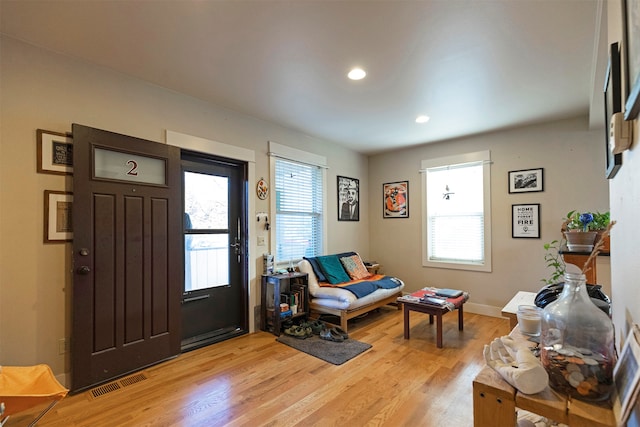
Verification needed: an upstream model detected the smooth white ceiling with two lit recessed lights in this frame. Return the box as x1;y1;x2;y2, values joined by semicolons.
0;0;607;153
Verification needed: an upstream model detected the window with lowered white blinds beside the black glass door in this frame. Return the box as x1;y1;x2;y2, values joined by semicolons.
275;158;324;263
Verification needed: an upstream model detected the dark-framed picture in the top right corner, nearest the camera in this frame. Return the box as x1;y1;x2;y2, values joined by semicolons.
622;0;640;120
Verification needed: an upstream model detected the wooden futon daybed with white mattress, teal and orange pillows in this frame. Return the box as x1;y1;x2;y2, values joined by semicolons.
298;252;404;331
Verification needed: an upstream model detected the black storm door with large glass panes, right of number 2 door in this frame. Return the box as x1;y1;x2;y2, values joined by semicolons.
182;154;248;351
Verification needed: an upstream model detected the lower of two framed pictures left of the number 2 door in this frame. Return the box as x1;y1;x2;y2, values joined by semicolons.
44;190;73;243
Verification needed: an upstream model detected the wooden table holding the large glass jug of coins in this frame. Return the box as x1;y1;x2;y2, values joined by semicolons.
473;328;616;427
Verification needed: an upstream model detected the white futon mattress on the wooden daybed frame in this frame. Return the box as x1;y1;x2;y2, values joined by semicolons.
298;259;404;310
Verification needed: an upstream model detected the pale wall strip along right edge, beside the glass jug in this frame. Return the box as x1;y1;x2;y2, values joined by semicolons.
607;0;640;349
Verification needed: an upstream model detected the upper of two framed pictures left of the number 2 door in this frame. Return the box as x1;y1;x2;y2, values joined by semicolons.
37;129;73;175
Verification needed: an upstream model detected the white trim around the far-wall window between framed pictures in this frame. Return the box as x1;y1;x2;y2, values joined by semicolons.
420;150;492;272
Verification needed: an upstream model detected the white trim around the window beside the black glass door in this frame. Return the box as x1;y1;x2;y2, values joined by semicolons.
268;141;327;269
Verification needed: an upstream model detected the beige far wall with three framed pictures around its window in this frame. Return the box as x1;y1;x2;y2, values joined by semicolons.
369;117;610;315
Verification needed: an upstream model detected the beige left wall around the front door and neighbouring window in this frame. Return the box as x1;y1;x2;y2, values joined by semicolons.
0;37;369;382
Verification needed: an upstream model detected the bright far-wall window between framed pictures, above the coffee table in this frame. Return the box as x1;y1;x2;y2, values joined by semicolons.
423;152;491;271
